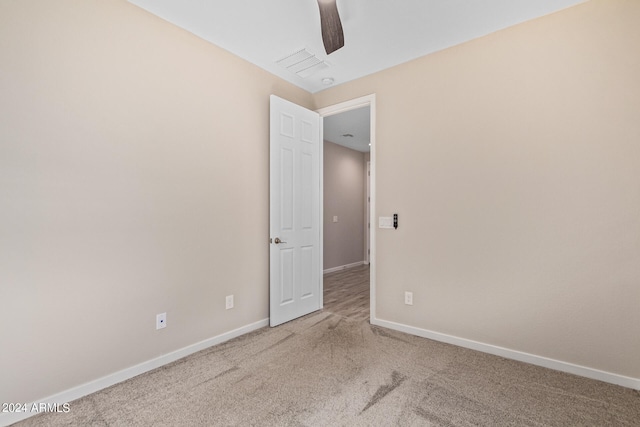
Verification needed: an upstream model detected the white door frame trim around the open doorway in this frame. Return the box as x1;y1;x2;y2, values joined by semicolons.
316;93;376;323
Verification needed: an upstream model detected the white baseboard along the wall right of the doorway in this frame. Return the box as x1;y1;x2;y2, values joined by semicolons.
371;319;640;390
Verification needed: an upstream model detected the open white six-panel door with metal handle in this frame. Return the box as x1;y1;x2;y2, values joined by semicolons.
269;95;322;326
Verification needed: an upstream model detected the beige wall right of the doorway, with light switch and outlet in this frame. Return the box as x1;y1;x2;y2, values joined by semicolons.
315;0;640;379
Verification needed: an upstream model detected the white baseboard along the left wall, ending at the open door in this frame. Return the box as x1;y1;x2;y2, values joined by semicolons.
0;319;269;426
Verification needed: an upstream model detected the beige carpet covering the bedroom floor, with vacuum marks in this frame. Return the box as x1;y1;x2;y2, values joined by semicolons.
19;311;640;426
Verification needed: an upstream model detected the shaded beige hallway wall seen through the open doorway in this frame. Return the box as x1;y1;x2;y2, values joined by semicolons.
323;141;366;270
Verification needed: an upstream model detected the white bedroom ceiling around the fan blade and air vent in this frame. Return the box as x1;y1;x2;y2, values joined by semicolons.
129;0;585;93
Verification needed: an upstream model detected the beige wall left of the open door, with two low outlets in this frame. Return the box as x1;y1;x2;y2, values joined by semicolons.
0;0;312;402
